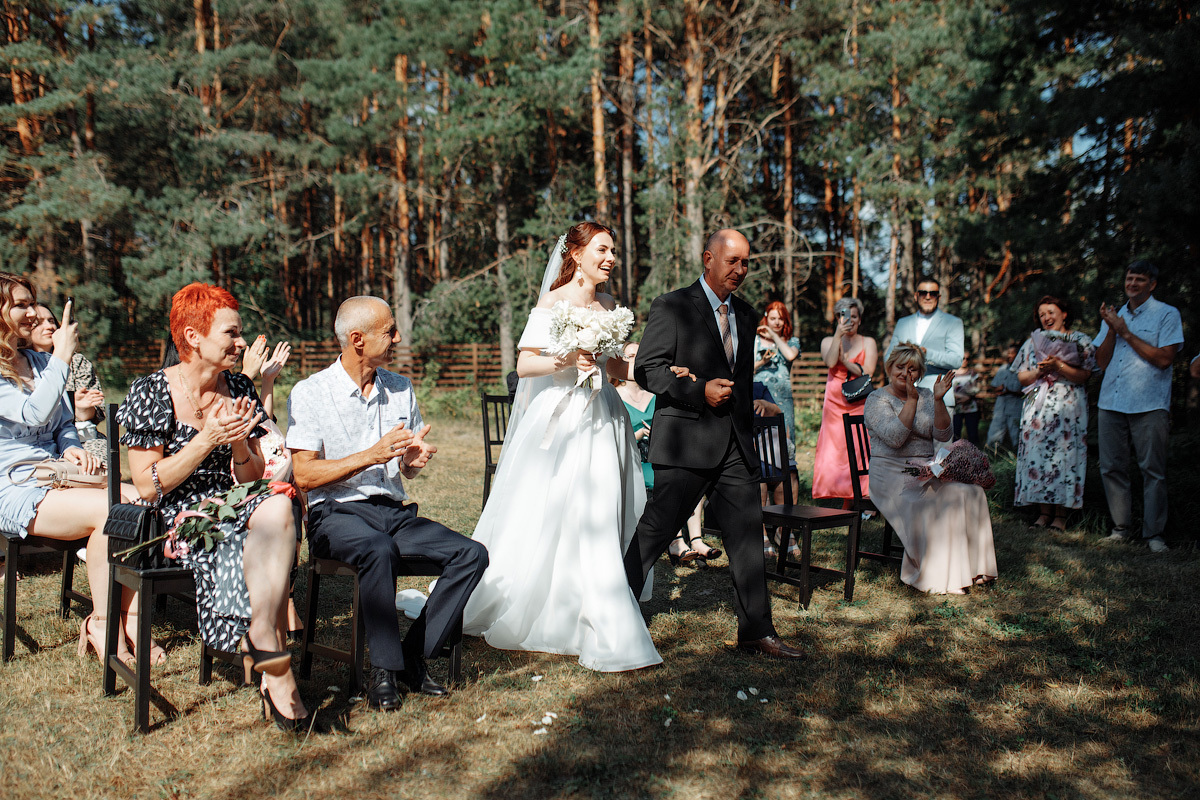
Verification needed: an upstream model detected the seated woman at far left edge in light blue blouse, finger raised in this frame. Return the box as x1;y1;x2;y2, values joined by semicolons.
0;272;142;662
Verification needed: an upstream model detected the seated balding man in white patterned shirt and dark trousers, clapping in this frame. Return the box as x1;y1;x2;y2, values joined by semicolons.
288;296;487;711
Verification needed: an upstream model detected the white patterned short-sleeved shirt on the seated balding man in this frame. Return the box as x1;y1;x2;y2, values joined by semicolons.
288;356;424;505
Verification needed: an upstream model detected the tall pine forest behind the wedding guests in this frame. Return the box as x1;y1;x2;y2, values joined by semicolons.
0;0;1200;371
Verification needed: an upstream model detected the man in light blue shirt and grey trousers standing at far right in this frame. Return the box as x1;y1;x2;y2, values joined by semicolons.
1096;260;1183;553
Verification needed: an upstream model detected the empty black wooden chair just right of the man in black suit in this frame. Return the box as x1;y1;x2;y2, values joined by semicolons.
754;416;862;608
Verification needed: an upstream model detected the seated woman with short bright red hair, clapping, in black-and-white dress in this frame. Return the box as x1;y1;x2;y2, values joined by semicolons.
118;283;308;730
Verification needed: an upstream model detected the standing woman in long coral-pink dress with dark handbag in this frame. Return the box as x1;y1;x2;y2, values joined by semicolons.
812;297;880;509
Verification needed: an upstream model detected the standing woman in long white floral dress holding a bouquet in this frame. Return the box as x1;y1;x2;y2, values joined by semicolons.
1013;295;1096;530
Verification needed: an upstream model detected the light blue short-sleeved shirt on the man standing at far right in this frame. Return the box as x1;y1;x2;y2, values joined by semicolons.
1093;296;1183;414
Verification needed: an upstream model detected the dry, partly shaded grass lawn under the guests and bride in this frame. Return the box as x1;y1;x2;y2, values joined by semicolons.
0;417;1200;800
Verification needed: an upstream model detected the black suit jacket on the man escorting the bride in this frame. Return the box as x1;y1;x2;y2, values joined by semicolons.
634;278;758;471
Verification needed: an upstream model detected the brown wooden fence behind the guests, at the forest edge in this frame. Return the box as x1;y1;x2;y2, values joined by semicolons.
100;339;1003;402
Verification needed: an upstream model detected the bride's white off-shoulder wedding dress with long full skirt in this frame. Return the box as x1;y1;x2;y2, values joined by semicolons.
463;308;662;672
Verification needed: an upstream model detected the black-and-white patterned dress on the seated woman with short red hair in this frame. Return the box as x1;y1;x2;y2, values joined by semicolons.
116;369;270;652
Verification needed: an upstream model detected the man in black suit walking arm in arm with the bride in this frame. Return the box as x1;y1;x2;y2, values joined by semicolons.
625;229;804;658
